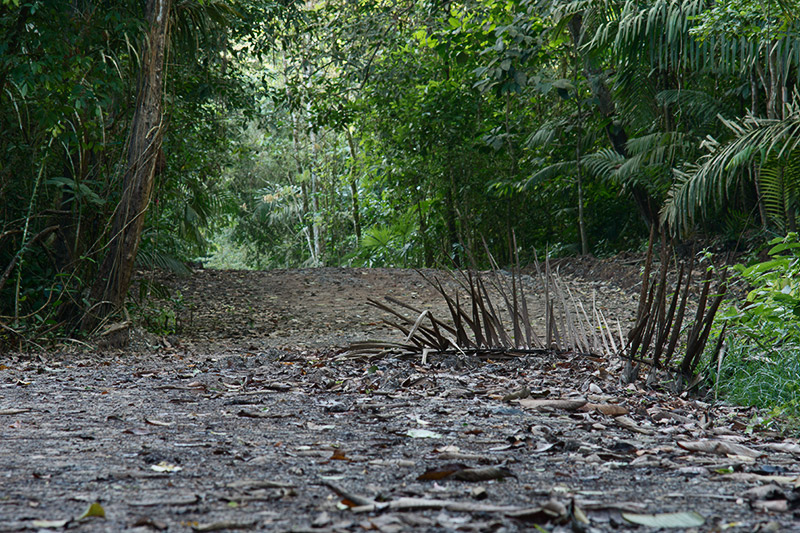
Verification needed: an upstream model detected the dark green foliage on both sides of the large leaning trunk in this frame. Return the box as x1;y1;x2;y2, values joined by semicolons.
0;0;286;333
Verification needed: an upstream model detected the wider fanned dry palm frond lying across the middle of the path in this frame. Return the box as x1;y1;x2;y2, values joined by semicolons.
344;245;615;360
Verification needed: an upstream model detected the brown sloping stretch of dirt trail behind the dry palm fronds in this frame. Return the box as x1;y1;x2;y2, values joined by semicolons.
145;268;636;351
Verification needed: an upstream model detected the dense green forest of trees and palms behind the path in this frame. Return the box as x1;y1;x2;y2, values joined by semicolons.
0;0;800;414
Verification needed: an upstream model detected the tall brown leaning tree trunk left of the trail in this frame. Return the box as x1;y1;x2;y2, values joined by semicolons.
83;0;172;329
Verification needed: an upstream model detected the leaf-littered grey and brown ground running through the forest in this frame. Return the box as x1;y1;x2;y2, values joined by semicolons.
0;260;800;532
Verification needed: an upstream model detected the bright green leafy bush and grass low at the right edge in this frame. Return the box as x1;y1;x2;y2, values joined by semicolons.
716;233;800;424
